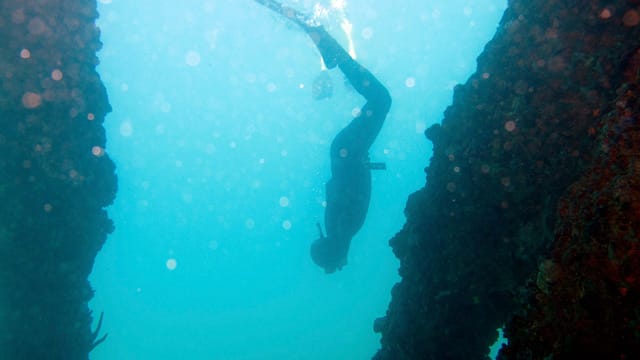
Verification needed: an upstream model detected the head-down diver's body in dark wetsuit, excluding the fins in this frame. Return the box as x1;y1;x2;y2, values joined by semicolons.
306;27;391;273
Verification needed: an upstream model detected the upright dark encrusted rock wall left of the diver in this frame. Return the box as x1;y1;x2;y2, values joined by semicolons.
0;0;116;359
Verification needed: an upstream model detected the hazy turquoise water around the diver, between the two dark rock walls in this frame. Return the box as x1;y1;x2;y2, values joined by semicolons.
90;0;506;360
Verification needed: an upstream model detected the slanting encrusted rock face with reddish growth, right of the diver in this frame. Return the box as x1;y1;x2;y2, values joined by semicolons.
375;0;640;360
